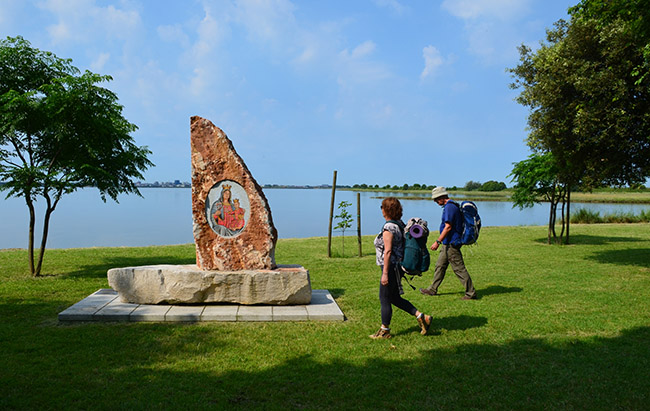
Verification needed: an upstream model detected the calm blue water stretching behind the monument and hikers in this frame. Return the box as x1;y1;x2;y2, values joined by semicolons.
0;188;650;248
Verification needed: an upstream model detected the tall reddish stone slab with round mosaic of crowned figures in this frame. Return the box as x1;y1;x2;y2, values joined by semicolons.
190;116;278;270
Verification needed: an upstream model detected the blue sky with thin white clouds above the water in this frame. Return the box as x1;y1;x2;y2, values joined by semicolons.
0;0;578;187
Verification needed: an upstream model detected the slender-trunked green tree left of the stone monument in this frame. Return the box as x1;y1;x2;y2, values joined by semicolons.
0;37;153;276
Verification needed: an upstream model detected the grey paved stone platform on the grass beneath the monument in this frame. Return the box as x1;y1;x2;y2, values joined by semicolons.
59;288;345;322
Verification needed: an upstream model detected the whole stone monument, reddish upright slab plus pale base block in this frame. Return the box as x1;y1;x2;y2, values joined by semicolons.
108;116;311;305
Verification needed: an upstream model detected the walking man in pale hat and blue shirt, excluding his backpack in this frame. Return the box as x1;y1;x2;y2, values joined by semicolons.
420;187;476;300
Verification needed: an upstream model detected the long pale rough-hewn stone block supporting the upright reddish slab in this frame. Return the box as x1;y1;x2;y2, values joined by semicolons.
108;265;311;305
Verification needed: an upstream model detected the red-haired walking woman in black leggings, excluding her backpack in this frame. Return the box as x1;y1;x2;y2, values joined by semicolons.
370;197;431;339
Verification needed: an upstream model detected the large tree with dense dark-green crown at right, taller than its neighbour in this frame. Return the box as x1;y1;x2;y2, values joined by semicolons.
510;5;650;242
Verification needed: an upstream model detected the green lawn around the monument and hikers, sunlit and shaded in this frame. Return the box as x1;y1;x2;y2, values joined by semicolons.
0;224;650;410
